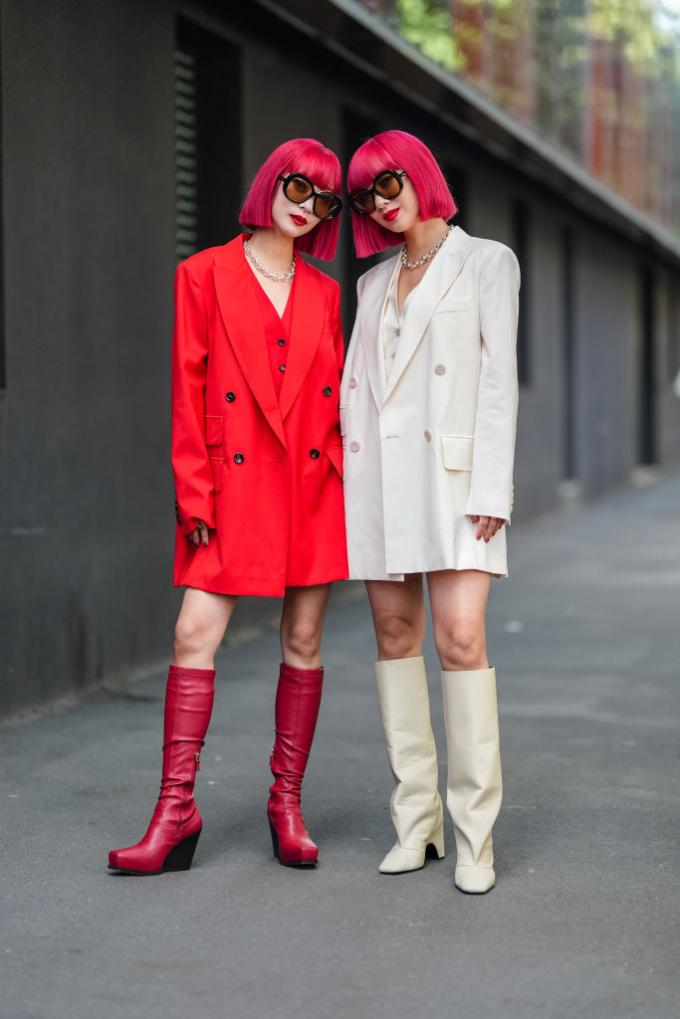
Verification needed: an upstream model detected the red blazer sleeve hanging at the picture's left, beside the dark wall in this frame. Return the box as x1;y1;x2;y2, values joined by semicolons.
172;262;215;534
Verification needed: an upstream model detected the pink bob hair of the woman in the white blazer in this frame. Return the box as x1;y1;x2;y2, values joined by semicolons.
347;130;458;258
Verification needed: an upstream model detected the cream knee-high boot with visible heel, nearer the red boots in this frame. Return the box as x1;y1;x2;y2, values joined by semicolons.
374;657;443;874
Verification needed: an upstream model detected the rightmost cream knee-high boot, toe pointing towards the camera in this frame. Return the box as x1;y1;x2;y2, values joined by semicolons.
441;668;503;895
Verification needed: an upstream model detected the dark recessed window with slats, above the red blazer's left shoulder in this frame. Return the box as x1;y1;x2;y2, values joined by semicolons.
174;19;243;261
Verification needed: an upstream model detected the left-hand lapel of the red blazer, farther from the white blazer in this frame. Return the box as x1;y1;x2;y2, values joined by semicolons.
213;236;285;445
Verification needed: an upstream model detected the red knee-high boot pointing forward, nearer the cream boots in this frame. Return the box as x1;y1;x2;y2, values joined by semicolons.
267;664;323;867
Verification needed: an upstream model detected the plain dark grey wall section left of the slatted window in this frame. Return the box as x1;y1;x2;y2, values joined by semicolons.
0;0;174;711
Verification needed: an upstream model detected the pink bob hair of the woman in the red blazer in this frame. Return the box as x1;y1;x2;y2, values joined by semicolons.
239;138;343;259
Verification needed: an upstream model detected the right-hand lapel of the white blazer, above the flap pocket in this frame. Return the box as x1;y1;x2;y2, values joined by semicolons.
383;227;468;403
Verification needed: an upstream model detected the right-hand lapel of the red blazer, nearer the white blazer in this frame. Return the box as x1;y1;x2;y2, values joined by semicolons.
279;256;326;418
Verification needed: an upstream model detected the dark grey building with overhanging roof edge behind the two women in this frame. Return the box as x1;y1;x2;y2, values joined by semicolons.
0;0;680;713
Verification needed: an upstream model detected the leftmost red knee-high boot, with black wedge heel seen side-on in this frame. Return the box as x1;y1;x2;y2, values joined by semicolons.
109;665;215;874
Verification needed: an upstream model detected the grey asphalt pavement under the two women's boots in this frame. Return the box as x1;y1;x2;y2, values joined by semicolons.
0;474;680;1019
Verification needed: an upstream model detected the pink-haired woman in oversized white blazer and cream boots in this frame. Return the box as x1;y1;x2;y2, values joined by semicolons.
341;130;520;894
